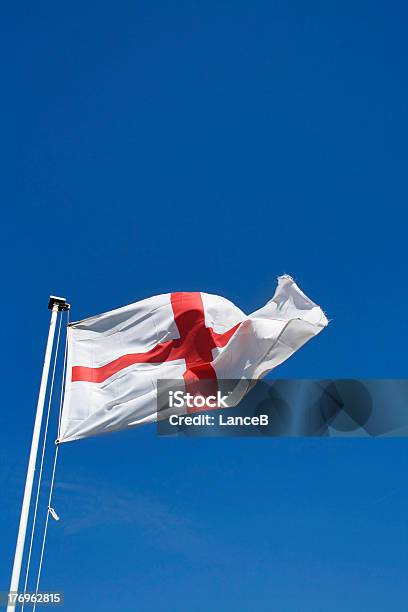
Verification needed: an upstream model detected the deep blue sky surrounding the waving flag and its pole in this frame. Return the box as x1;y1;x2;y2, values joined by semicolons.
0;0;408;612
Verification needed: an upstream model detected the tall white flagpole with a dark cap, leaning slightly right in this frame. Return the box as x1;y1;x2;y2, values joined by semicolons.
7;295;69;612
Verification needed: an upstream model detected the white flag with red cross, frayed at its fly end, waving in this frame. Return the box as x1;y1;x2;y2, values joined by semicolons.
60;276;328;442
